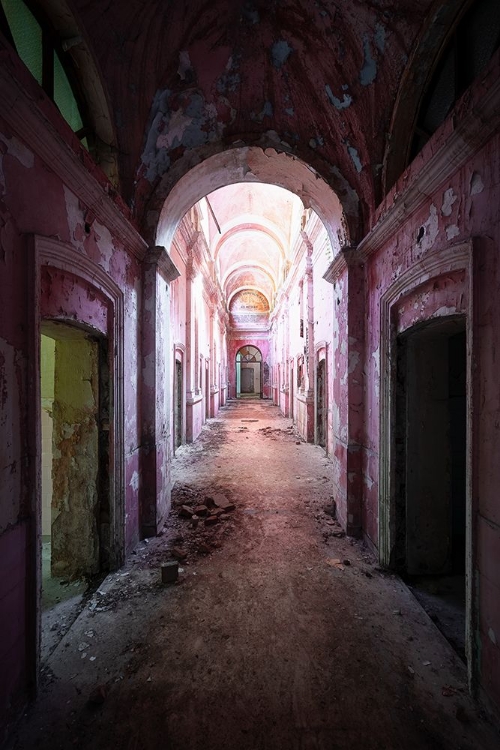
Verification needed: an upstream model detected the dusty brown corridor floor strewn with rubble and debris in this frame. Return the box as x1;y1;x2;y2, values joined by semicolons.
7;402;500;750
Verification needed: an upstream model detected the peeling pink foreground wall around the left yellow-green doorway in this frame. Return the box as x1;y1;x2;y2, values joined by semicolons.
0;110;140;736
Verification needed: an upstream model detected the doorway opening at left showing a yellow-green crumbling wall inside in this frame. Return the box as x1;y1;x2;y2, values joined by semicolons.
40;321;110;629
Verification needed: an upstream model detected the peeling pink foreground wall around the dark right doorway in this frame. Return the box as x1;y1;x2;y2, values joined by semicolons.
363;94;500;707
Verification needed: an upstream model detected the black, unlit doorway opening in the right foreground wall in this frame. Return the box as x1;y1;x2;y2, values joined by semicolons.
395;317;467;659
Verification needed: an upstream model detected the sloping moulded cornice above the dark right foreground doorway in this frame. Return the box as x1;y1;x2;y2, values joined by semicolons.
359;63;500;258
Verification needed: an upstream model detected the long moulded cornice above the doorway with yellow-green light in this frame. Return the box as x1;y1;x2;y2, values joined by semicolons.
0;57;147;260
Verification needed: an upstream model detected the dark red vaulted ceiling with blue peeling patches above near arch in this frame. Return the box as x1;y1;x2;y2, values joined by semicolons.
72;0;440;232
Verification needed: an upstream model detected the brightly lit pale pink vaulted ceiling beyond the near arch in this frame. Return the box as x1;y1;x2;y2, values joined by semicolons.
198;183;304;310
